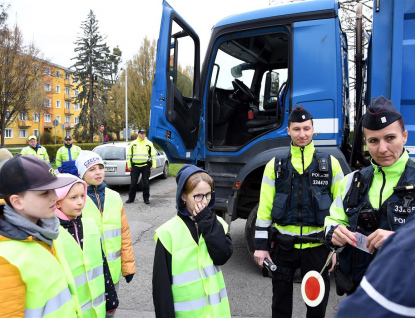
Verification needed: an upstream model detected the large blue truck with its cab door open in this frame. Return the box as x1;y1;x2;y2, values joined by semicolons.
149;0;415;254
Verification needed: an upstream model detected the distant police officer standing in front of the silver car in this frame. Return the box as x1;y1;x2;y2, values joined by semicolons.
125;128;156;204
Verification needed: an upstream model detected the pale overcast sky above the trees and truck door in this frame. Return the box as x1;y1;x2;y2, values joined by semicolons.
7;0;269;68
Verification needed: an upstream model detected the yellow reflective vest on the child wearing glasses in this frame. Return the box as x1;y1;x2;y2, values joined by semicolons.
154;215;231;318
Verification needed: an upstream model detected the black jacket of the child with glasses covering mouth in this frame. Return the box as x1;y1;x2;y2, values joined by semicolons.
153;208;233;318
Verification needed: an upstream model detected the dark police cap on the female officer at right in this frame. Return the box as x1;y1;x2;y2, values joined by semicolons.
362;96;402;130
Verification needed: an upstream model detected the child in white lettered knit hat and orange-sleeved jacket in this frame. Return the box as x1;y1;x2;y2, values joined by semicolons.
75;150;135;317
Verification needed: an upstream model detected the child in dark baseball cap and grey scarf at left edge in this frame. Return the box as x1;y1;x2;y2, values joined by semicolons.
0;155;77;317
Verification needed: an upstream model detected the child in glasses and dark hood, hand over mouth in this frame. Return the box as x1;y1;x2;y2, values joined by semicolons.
153;165;233;318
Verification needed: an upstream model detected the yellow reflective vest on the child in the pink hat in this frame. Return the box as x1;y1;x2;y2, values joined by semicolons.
55;217;106;318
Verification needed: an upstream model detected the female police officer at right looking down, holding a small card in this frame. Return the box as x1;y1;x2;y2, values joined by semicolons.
325;96;415;294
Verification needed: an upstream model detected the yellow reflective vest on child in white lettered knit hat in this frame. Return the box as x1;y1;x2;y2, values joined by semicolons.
82;188;122;284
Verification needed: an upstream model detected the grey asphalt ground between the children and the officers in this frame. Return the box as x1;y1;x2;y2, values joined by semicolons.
109;177;340;318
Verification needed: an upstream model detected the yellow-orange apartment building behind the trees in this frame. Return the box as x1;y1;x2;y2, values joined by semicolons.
4;63;81;146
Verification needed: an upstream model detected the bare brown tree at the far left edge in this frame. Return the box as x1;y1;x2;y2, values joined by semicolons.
0;5;47;145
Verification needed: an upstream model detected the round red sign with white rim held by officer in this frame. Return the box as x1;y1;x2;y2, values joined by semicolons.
301;271;326;307
